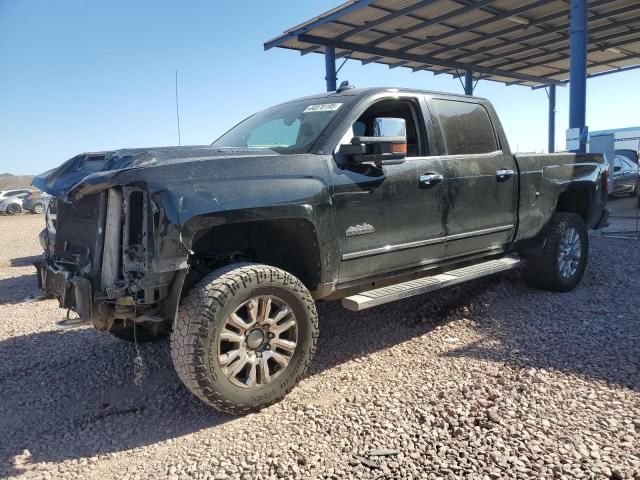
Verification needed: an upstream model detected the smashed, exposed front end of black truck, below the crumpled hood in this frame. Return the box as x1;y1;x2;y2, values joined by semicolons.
36;186;188;333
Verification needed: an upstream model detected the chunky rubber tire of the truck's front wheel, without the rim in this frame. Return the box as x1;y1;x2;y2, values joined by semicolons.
171;263;318;415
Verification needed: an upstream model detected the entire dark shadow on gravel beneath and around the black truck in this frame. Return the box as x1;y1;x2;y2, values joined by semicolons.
0;240;640;477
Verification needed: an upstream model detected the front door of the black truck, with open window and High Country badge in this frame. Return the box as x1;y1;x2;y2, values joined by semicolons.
333;96;444;283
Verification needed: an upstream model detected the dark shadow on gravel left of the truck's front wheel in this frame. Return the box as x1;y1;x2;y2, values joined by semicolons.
0;327;232;478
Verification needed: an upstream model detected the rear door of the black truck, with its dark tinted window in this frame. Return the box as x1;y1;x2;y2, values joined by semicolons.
429;96;518;258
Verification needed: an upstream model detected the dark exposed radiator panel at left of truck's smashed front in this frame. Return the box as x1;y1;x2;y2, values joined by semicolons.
55;192;106;271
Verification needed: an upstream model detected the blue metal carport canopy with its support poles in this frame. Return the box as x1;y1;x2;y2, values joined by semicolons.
264;0;640;150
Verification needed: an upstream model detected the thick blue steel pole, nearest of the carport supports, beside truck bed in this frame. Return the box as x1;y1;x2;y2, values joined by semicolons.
569;0;587;153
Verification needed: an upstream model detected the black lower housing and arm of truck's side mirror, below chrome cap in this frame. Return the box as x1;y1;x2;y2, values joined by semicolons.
338;137;407;167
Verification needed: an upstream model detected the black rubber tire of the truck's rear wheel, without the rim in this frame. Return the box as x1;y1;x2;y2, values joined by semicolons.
525;213;589;292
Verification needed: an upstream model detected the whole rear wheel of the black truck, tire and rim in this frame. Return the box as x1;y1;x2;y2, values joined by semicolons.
526;213;589;292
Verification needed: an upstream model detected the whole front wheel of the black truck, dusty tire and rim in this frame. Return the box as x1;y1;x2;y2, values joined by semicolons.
171;264;318;414
